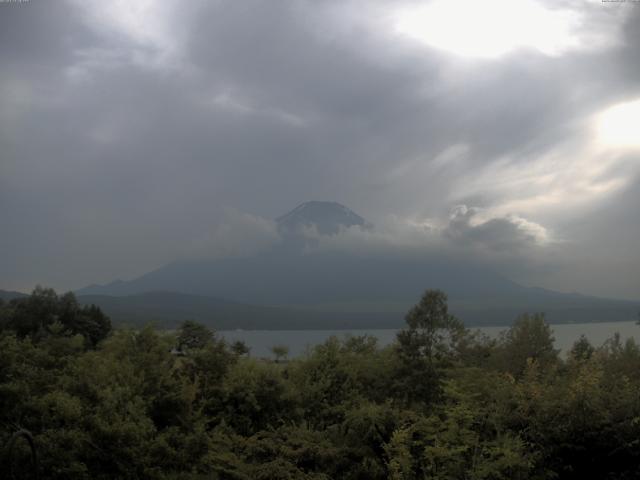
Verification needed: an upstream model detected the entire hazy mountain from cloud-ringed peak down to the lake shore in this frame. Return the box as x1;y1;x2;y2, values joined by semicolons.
77;202;638;328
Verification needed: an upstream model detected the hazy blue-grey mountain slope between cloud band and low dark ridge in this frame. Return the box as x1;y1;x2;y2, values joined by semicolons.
78;249;522;305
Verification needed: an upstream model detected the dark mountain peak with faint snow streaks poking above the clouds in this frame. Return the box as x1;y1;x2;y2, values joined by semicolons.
276;200;365;235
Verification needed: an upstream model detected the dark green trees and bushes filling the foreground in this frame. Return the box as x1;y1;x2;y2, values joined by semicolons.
0;289;640;480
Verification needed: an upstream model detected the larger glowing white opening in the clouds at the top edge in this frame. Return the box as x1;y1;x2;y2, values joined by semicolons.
395;0;580;58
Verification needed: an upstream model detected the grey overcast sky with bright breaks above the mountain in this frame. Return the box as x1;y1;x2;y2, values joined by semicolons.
0;0;640;299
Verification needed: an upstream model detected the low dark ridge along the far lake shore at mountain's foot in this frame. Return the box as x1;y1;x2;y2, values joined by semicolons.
78;292;637;330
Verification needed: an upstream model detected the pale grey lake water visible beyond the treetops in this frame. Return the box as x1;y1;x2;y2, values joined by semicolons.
218;322;640;357
